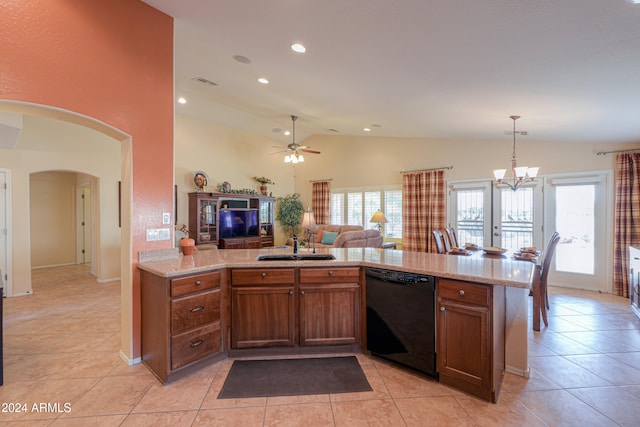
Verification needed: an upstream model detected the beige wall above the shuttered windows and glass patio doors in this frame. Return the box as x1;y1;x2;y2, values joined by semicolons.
295;136;640;203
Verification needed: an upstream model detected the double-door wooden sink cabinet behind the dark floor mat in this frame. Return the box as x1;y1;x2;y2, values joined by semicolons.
231;267;361;349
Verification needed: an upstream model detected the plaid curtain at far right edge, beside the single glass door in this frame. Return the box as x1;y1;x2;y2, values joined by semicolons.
613;153;640;298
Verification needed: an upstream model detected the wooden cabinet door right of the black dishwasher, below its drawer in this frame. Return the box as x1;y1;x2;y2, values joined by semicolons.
437;299;491;392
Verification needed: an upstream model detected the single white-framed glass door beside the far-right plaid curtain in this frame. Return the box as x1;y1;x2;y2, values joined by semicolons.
545;172;613;292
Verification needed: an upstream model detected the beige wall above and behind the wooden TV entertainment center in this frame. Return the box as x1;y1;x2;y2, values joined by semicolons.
175;115;295;245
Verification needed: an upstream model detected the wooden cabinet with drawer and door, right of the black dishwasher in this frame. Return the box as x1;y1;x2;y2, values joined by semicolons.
436;279;505;402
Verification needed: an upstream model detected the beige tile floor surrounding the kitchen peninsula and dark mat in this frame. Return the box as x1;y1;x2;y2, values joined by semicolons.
0;266;640;427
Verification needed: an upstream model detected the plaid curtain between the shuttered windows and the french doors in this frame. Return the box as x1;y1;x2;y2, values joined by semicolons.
402;170;446;252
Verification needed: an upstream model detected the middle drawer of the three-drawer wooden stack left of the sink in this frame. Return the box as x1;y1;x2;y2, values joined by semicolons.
171;289;220;334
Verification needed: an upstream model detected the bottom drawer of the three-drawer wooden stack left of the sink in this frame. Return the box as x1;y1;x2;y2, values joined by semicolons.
171;322;220;369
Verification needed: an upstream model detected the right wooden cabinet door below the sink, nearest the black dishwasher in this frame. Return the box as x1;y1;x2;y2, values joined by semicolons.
300;283;360;345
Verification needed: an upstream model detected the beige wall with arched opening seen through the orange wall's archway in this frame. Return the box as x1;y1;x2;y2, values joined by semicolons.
0;116;121;295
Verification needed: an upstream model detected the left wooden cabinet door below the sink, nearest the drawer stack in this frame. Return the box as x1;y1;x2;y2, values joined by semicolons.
231;286;295;348
